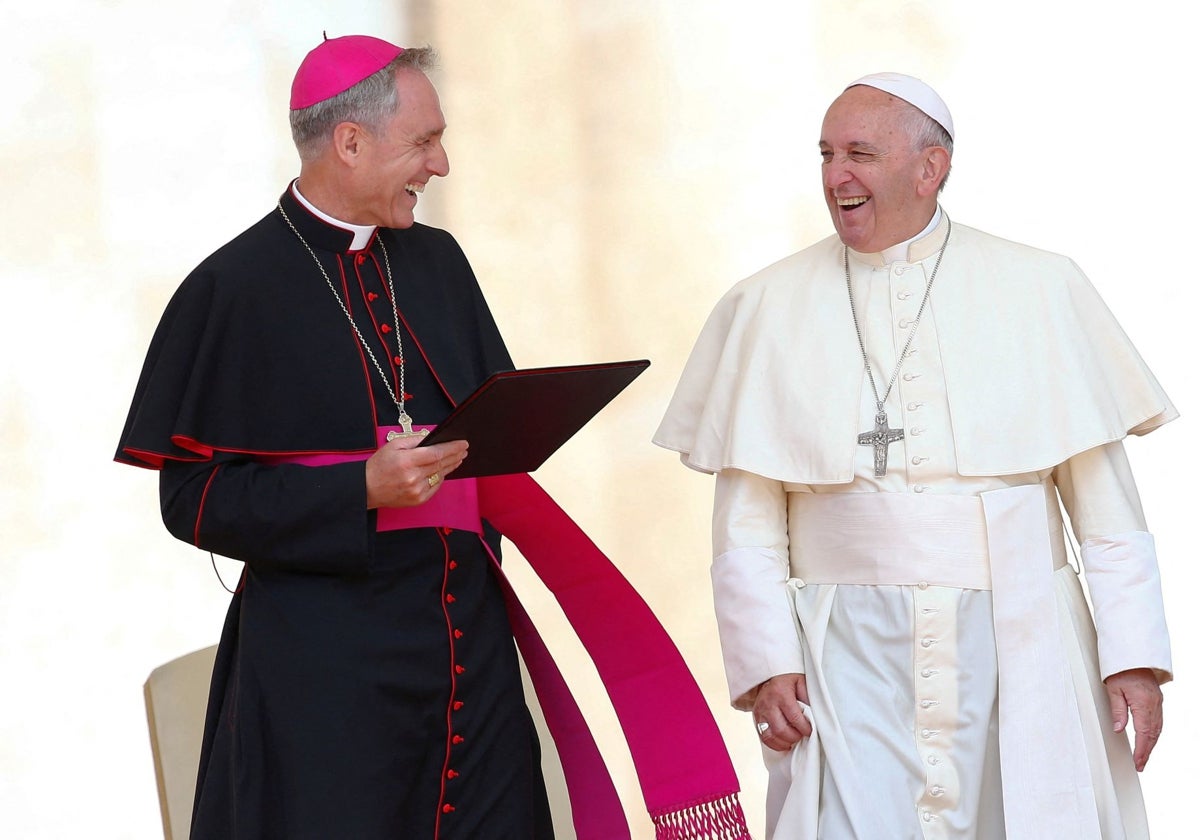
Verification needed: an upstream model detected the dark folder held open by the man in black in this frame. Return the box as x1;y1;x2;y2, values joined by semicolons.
420;359;650;479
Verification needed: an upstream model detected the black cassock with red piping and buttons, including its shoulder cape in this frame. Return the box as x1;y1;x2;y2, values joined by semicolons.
116;191;552;840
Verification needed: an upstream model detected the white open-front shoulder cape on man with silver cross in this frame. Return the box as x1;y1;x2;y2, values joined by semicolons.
654;218;1178;485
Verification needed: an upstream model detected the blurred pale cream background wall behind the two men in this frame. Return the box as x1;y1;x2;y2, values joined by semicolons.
0;0;1200;838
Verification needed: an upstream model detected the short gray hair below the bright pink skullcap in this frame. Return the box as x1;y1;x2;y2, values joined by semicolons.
288;47;437;161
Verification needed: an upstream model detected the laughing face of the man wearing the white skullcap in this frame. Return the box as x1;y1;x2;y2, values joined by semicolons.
821;85;949;253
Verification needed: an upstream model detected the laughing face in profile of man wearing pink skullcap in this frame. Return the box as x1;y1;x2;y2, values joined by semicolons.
346;70;450;228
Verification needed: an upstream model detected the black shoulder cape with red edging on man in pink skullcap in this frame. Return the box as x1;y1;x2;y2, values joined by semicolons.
115;191;512;468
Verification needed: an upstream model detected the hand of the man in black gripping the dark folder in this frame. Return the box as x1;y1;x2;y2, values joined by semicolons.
367;438;467;508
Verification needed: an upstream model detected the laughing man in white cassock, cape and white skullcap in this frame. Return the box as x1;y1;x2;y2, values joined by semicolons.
655;73;1177;840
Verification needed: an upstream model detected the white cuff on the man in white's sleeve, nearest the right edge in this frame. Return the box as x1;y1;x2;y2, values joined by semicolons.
1081;530;1171;683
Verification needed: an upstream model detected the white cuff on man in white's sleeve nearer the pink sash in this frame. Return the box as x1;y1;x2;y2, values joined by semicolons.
712;548;804;710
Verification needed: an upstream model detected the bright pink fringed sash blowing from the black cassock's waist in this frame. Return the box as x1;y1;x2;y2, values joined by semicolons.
264;427;750;840
